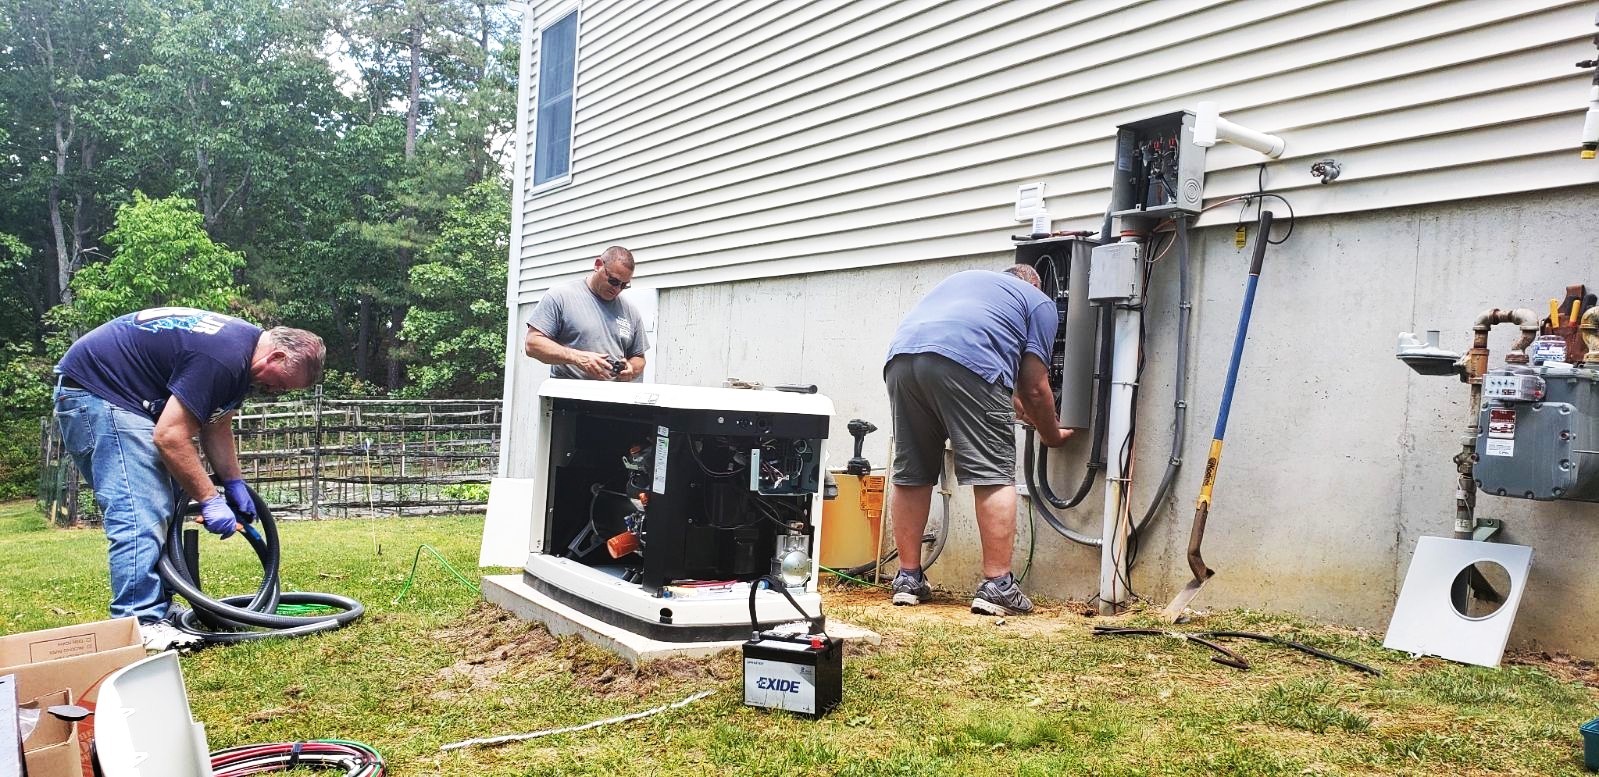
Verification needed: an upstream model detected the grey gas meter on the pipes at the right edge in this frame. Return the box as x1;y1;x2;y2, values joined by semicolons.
1473;366;1599;502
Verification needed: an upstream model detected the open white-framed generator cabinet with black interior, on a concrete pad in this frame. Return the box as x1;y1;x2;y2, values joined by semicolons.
523;379;833;643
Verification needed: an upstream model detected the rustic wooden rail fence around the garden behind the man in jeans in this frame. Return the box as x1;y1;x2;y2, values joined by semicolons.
40;390;500;524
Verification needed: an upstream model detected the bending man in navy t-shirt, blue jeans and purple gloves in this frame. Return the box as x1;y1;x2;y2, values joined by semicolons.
54;307;326;651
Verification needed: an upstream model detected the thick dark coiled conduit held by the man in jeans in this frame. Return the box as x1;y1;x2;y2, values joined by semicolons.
157;489;366;642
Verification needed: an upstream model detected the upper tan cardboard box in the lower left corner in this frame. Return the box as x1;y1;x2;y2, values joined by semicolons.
0;617;144;705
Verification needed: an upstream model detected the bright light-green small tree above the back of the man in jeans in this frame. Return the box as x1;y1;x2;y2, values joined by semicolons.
54;192;245;329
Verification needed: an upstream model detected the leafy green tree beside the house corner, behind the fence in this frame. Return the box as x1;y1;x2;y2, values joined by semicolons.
401;179;510;396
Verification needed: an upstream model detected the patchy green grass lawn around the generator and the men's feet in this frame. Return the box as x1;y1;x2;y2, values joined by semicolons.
0;502;1599;777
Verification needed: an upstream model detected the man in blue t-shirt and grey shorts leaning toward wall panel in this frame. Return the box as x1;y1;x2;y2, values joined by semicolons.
883;264;1071;616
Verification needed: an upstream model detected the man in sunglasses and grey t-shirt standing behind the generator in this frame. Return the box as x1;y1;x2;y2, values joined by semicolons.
524;246;649;381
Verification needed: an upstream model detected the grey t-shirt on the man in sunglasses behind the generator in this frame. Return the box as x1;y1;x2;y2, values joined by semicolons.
528;278;649;381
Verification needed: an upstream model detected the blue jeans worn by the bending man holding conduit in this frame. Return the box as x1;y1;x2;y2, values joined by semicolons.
56;385;177;624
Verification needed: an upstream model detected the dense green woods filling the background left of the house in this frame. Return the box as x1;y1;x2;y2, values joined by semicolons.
0;0;520;401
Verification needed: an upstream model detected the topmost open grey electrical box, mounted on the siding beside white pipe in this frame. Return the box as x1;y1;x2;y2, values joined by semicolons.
1111;110;1206;217
